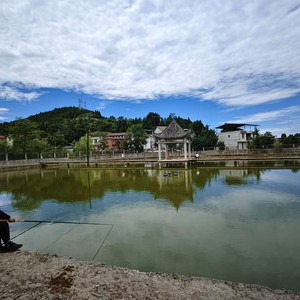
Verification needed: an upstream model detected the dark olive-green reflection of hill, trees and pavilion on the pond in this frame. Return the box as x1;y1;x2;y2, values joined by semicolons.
0;169;263;210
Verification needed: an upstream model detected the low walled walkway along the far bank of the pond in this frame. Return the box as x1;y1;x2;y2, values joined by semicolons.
0;148;300;170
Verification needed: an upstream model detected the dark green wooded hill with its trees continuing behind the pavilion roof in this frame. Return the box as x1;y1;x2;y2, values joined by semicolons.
0;107;217;152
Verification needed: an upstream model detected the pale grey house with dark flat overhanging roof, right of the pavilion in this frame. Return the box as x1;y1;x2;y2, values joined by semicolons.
216;123;259;150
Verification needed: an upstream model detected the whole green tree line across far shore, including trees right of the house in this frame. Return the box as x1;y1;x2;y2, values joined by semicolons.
0;107;300;154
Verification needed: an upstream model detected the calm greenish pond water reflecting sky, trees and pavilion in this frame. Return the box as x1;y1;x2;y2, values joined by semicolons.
0;167;300;291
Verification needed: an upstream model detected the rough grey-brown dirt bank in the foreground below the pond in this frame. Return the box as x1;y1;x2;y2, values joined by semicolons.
0;251;300;300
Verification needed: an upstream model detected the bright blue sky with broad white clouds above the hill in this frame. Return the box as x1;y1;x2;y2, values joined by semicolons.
0;0;300;136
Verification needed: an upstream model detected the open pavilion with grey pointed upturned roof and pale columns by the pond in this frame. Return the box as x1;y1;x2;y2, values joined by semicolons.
154;119;191;166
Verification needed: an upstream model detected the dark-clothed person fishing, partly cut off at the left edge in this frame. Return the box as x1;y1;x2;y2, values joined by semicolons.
0;210;23;253
